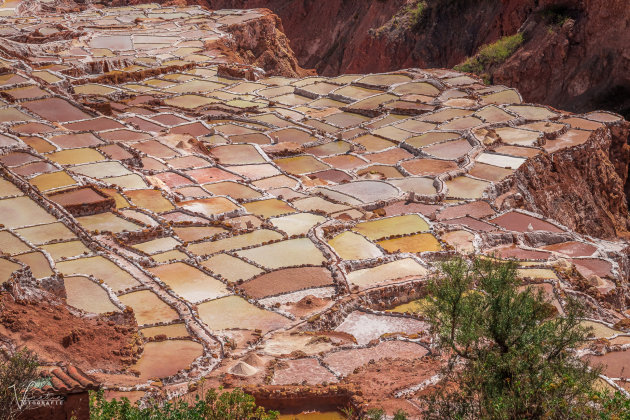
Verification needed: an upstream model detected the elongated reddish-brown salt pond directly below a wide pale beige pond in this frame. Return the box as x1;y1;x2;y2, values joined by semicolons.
240;267;333;299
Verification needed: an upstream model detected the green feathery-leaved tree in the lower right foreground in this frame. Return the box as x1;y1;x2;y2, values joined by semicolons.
425;258;628;419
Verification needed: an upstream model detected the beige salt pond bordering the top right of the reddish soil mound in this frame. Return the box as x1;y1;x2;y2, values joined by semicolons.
63;276;120;314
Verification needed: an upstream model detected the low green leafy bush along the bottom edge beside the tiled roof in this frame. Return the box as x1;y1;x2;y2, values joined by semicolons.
90;388;279;420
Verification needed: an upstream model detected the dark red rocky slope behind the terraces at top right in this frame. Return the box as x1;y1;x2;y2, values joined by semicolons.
191;0;630;116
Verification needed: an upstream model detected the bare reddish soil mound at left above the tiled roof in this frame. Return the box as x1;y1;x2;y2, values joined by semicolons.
0;292;140;370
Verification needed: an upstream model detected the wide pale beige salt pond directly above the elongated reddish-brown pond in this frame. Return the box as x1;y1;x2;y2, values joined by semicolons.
236;238;326;269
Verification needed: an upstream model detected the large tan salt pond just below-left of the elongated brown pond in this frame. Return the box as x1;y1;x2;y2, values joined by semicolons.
198;296;289;334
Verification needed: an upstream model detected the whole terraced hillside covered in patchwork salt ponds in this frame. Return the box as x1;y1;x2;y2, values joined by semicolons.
0;1;630;413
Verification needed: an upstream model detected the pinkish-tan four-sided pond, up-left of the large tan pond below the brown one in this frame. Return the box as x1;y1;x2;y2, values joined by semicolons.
148;262;228;303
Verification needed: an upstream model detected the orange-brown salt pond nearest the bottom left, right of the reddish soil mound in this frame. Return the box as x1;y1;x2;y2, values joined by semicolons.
133;340;203;380
